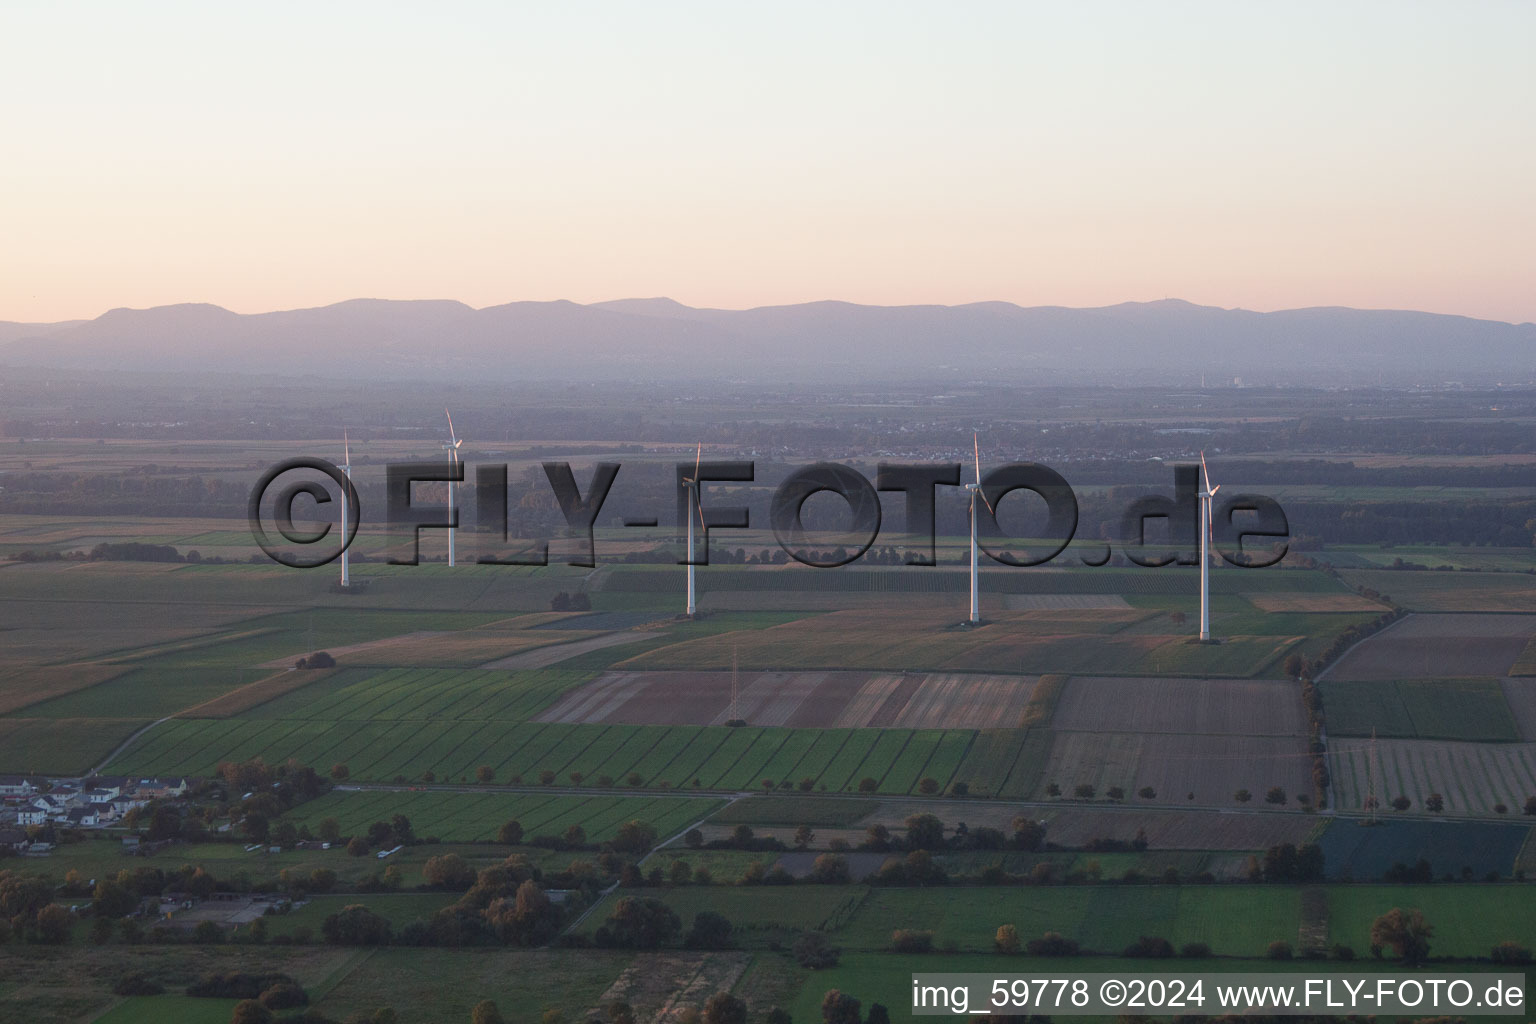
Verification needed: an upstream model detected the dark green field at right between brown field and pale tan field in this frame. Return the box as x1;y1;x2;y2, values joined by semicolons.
1322;679;1521;743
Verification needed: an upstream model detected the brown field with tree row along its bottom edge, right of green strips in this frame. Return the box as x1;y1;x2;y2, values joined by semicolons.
1035;732;1312;808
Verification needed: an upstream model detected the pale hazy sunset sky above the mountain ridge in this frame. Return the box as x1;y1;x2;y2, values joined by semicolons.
0;0;1536;321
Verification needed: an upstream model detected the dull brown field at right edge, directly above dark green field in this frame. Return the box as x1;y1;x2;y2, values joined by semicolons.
1327;614;1536;680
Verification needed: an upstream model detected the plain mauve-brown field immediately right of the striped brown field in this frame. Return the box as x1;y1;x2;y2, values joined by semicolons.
1051;676;1306;735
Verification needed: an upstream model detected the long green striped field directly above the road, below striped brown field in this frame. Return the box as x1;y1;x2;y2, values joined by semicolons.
102;718;975;794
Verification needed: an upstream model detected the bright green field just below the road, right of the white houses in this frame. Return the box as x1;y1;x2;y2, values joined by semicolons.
289;791;723;843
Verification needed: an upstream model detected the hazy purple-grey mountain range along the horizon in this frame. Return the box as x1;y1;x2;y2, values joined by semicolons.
0;298;1536;385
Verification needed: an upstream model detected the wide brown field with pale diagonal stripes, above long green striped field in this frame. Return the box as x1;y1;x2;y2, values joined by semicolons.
538;672;1034;729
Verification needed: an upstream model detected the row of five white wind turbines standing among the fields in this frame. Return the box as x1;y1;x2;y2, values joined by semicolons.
338;408;1221;643
